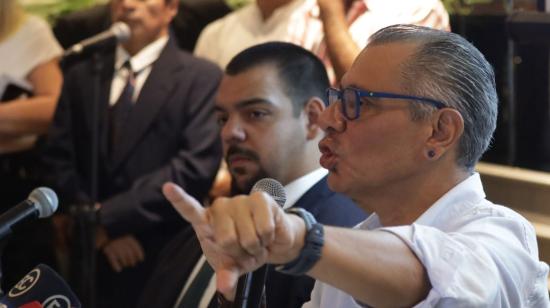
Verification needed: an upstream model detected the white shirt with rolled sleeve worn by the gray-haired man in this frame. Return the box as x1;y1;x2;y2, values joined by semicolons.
304;173;550;308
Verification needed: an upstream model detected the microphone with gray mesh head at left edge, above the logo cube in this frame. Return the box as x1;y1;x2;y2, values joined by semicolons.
0;187;58;239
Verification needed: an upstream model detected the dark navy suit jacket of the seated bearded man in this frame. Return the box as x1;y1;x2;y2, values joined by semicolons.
138;177;366;308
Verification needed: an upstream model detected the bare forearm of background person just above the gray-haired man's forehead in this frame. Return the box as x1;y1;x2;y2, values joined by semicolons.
321;6;366;81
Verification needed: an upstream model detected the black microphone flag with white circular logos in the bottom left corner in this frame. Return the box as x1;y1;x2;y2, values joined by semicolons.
0;264;81;308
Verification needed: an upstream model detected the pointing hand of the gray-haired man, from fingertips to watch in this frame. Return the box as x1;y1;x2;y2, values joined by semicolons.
163;179;305;299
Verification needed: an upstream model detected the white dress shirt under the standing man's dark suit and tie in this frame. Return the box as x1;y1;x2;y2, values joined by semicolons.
109;35;169;106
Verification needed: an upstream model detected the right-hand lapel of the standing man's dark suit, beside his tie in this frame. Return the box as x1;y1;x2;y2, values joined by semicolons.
112;39;187;169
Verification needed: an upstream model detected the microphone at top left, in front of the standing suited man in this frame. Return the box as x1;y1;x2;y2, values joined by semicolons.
63;21;131;57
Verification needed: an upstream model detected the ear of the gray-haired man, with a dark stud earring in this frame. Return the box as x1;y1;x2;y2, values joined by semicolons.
424;108;464;159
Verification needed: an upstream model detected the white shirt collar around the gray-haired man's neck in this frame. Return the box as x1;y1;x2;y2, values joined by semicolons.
359;172;485;230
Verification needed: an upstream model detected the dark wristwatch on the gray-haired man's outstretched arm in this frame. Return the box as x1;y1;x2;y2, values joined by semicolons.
275;207;325;276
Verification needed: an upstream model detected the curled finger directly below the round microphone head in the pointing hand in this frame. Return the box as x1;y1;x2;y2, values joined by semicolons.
250;192;279;246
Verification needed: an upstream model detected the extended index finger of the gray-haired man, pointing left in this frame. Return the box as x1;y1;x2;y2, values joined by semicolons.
162;182;207;225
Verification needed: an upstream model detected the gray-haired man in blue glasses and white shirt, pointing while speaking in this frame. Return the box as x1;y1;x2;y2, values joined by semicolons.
164;25;549;307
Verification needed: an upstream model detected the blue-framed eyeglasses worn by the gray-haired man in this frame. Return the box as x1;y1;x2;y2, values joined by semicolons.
327;87;447;121
